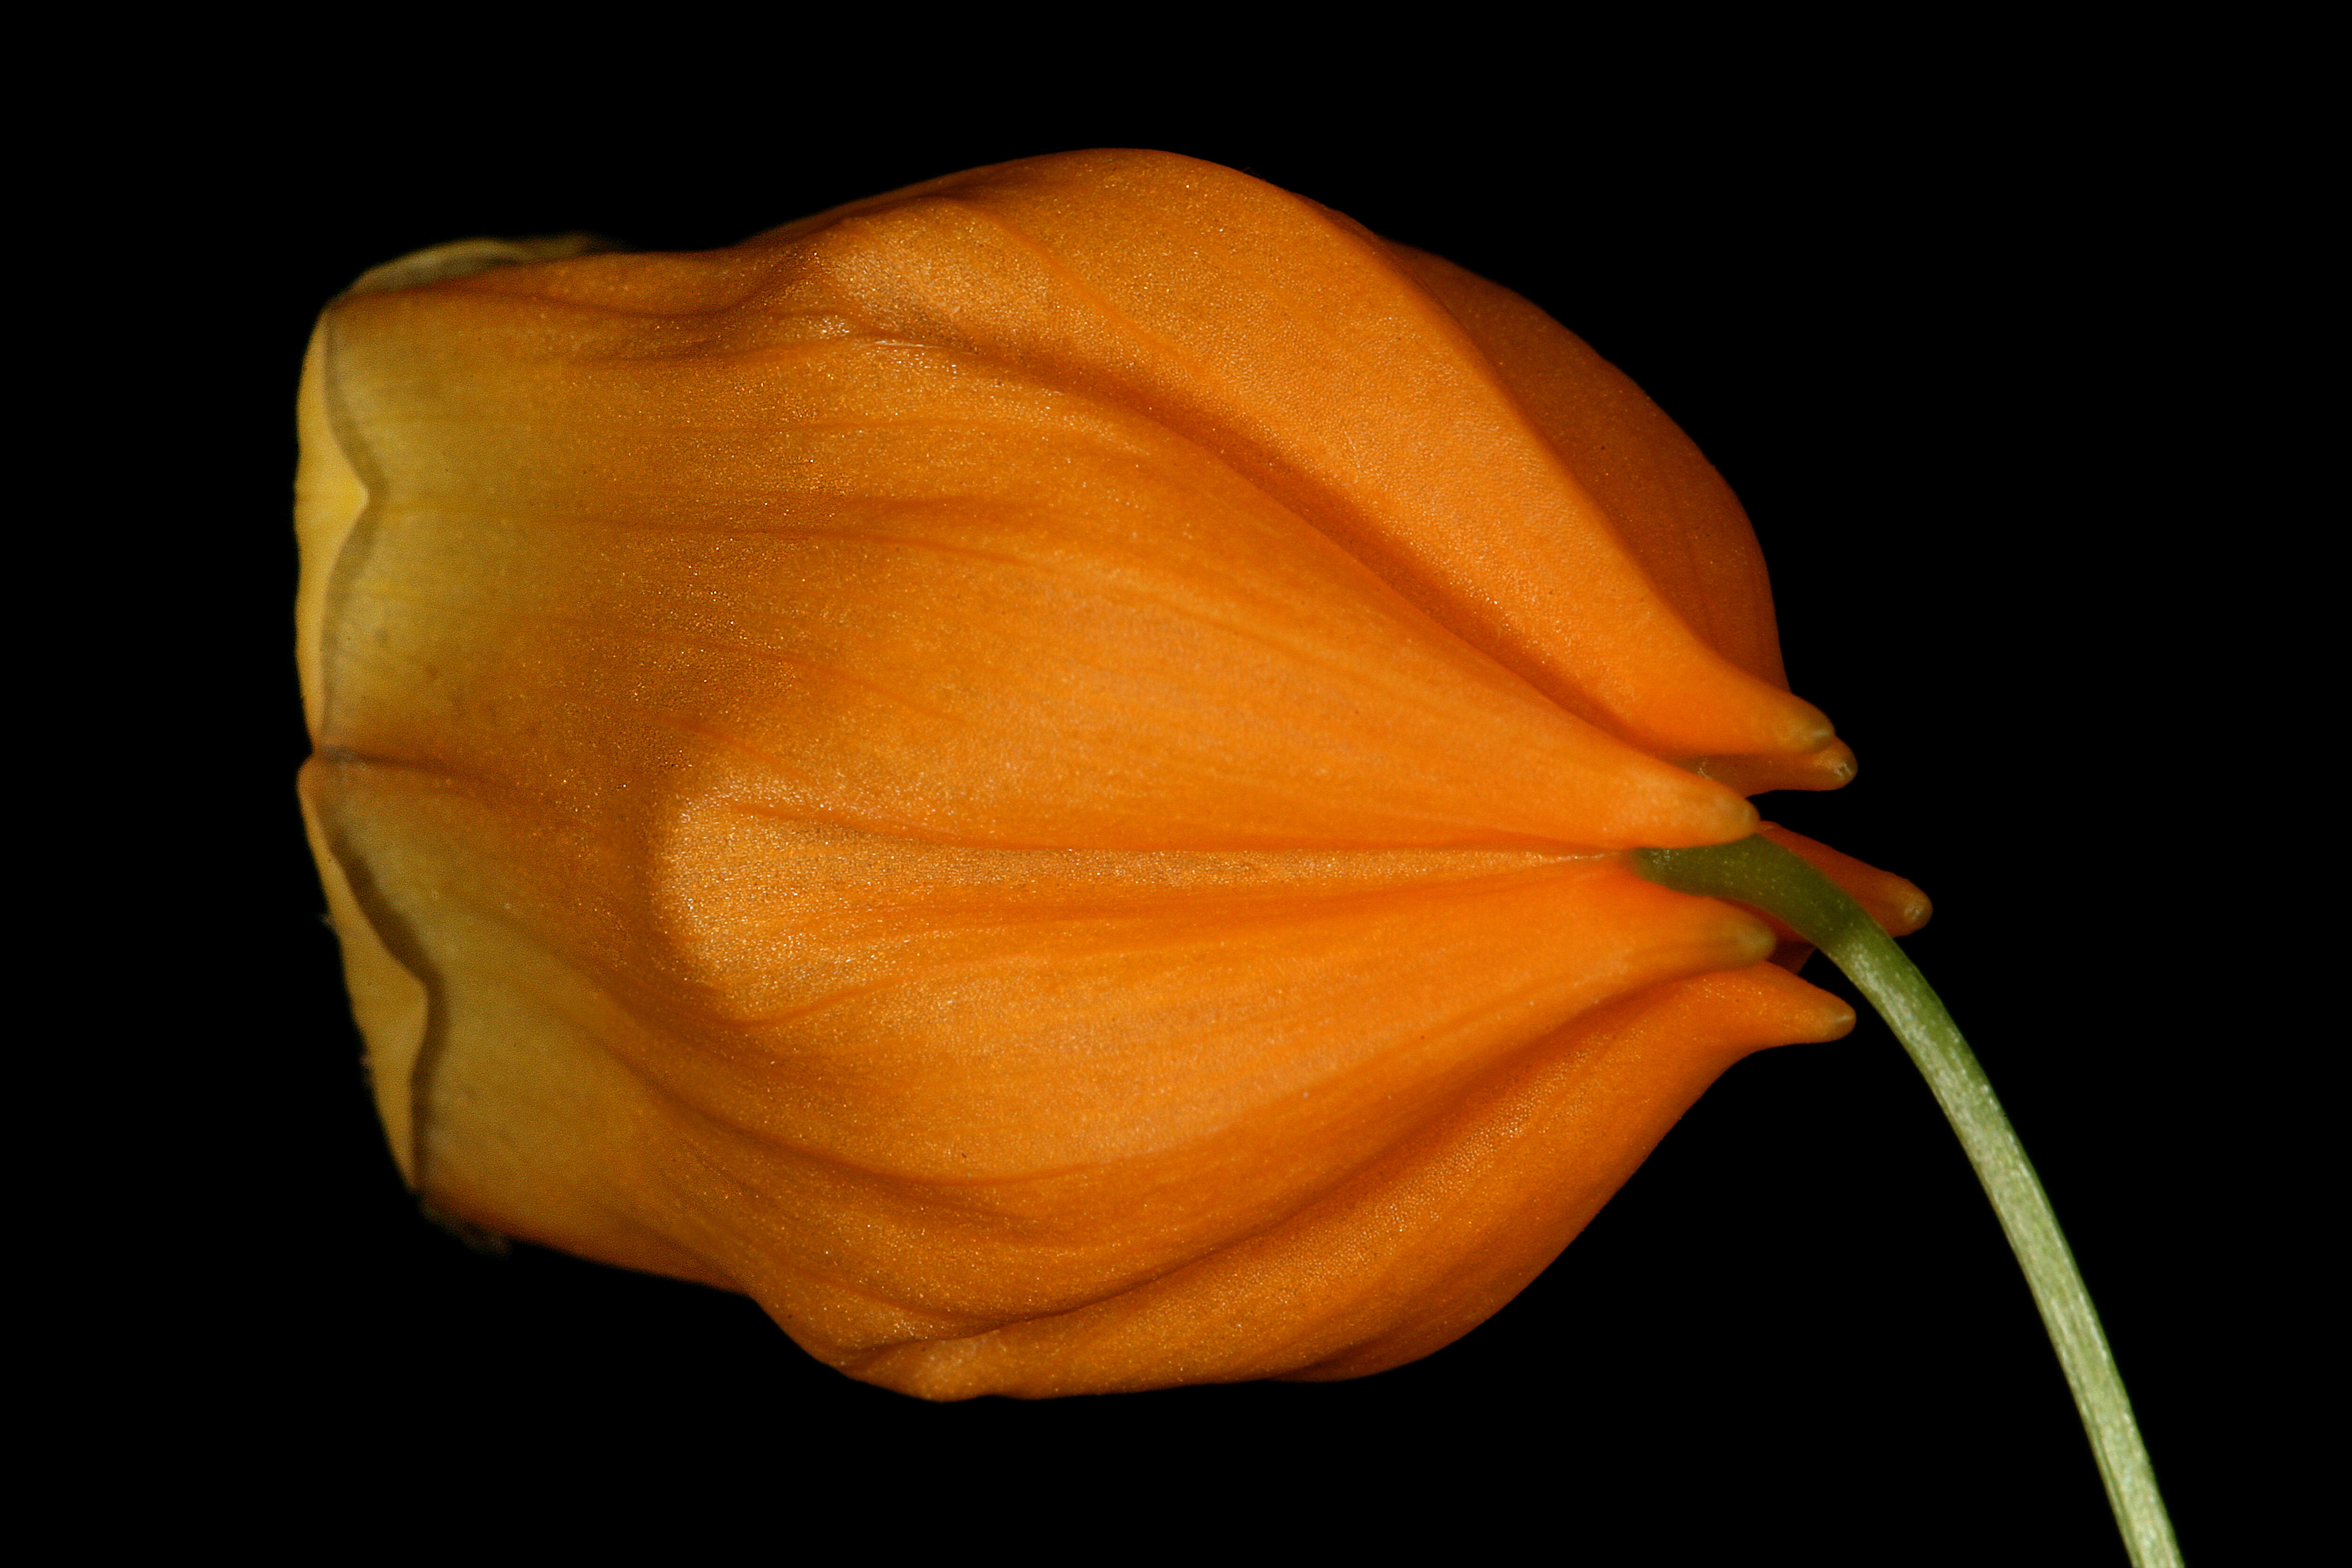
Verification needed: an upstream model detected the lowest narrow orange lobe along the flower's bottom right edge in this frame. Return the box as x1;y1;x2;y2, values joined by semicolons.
847;964;1854;1399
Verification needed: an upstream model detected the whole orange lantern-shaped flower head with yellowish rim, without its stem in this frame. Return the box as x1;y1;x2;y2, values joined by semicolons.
299;153;1924;1399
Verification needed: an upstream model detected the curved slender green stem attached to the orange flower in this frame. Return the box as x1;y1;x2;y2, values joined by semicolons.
1634;837;2180;1568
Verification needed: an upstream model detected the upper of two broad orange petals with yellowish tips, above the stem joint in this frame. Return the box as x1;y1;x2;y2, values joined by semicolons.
320;256;1752;849
